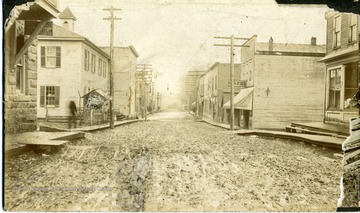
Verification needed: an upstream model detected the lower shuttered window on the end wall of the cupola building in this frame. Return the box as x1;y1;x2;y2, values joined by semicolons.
40;86;60;107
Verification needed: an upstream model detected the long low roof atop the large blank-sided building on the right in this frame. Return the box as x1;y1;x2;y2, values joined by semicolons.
256;42;325;53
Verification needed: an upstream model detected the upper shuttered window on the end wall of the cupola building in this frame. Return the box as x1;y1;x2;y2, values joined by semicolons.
41;46;61;68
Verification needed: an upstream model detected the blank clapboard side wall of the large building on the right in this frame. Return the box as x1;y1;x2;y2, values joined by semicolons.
253;55;325;129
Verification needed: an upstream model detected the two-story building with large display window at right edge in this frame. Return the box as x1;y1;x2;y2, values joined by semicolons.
320;12;360;123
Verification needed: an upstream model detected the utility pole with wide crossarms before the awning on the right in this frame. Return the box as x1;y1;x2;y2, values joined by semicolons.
214;35;249;130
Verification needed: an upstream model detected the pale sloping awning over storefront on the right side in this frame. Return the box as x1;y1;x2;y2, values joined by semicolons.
223;87;254;110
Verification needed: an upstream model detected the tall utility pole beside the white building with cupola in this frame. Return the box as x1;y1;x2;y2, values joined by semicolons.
104;6;121;129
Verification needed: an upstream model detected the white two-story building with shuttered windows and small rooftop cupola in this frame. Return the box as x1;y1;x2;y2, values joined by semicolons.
37;8;110;119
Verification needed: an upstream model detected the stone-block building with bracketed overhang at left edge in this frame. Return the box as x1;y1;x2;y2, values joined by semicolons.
4;0;59;133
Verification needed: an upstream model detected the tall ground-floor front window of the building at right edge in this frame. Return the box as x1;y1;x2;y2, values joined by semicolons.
328;68;341;109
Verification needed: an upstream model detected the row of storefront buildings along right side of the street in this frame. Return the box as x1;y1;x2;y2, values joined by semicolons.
196;12;360;129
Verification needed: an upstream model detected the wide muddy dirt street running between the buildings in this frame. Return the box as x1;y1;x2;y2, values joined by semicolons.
4;113;342;211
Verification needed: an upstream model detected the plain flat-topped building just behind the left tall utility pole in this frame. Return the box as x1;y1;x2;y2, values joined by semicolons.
101;46;140;117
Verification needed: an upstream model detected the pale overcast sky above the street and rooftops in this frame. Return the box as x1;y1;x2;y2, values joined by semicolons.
54;0;329;91
